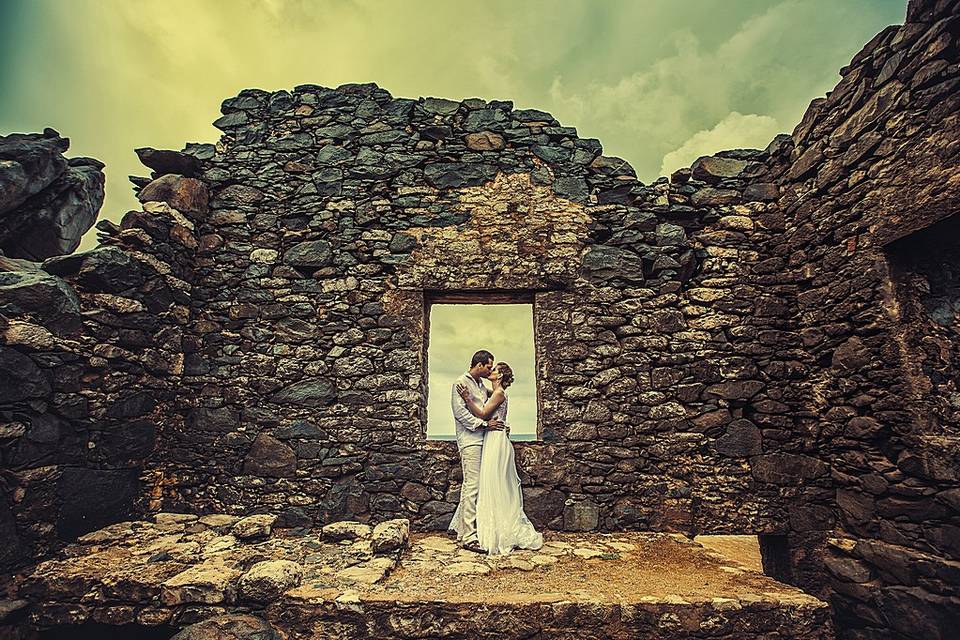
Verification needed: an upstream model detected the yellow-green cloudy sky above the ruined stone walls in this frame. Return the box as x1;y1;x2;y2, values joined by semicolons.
0;0;905;255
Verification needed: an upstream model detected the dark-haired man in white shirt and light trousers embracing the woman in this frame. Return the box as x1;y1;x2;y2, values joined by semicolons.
450;350;503;553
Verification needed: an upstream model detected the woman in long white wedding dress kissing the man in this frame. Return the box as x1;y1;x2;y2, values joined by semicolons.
449;362;543;555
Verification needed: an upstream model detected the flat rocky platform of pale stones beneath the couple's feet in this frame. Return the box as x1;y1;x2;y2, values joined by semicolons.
0;513;832;640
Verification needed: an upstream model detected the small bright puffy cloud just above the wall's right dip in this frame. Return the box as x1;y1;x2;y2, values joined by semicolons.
660;111;781;176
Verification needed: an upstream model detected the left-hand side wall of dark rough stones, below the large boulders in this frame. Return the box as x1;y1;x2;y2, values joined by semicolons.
0;165;206;569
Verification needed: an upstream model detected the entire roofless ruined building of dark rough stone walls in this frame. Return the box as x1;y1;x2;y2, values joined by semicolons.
0;0;960;639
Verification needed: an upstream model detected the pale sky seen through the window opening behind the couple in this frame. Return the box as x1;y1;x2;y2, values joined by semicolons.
427;304;537;440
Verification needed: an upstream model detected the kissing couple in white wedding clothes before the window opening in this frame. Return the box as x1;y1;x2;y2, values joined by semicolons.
449;351;543;555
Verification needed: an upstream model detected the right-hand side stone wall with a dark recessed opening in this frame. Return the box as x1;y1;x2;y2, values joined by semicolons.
771;1;960;638
